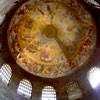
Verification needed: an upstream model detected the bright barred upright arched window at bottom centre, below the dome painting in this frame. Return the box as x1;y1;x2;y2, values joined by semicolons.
41;86;56;100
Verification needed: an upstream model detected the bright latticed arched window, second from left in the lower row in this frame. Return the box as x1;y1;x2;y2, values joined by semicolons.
17;79;32;99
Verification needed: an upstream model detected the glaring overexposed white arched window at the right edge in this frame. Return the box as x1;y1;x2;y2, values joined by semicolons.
88;67;100;88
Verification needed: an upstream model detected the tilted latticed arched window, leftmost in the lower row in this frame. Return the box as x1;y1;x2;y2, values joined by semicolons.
0;64;12;85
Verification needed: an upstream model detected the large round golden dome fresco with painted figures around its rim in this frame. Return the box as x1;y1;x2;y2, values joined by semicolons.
8;0;96;78
